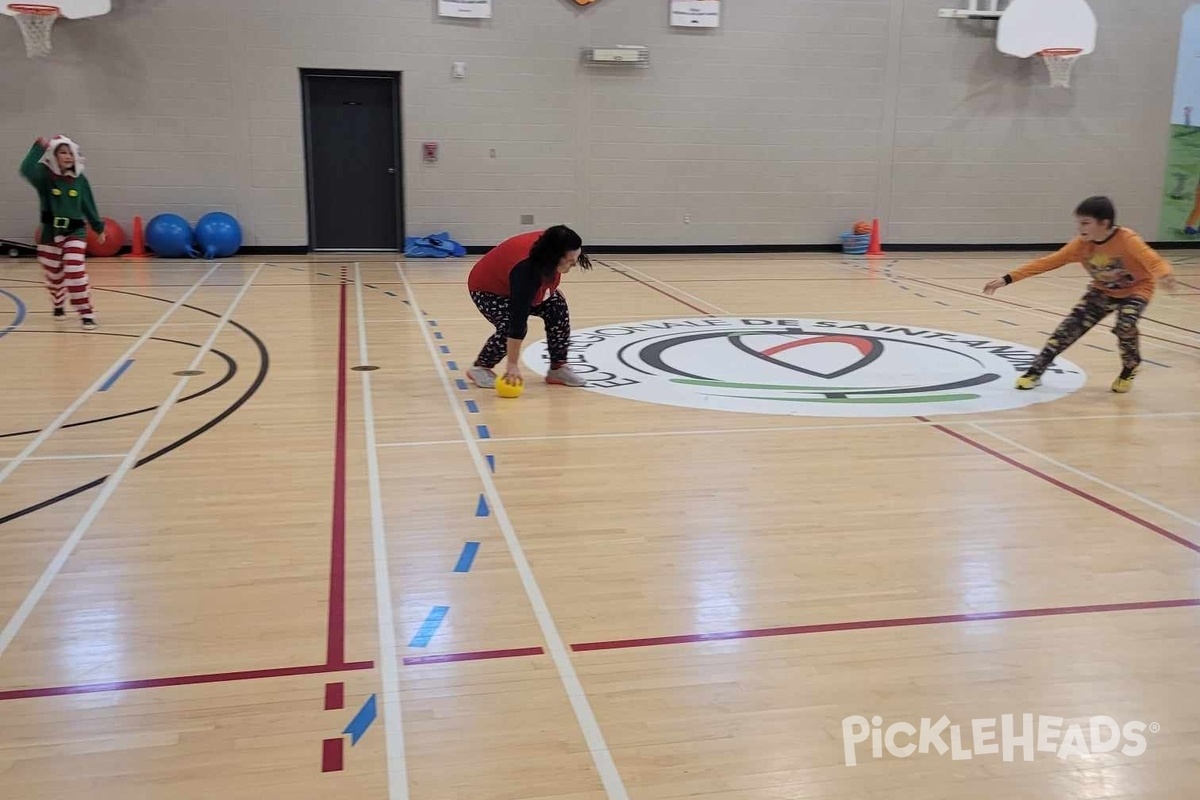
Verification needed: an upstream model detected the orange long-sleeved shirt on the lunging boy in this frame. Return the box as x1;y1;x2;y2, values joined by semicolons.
1008;228;1171;301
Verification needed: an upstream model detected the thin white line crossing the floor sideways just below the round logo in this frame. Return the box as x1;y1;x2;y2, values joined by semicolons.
376;411;1200;447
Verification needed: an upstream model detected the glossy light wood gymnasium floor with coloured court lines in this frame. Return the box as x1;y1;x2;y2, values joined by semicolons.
0;253;1200;800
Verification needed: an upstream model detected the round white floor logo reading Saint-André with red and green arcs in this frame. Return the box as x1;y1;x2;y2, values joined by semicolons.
523;317;1087;417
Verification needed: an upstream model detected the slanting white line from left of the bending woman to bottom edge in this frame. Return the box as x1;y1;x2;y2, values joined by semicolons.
396;261;629;800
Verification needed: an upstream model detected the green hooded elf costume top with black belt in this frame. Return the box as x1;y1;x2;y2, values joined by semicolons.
20;136;104;245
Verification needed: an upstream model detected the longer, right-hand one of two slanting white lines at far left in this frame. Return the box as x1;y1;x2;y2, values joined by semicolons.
0;264;262;656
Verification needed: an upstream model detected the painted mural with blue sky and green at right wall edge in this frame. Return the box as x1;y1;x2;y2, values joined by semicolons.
1158;4;1200;242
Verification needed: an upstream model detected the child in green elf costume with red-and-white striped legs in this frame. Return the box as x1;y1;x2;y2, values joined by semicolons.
20;136;104;330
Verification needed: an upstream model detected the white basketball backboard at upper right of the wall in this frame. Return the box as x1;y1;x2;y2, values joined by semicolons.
996;0;1098;59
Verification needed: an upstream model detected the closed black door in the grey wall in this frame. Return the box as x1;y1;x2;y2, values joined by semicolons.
300;70;404;251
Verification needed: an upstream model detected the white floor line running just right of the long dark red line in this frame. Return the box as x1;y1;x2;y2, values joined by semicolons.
354;264;408;800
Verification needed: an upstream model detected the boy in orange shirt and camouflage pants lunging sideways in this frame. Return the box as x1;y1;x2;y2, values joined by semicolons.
983;197;1175;393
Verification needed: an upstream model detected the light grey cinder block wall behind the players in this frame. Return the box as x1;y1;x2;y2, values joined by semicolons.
0;0;1190;246
